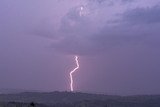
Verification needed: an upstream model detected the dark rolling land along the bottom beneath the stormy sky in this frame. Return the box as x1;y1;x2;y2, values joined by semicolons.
0;92;160;107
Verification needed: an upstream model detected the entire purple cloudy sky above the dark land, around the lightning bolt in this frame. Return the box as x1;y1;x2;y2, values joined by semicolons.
0;0;160;95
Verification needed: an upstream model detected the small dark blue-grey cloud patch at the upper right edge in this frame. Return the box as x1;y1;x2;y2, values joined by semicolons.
123;5;160;24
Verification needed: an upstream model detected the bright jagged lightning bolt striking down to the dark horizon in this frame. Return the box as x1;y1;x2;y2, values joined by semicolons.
70;56;79;91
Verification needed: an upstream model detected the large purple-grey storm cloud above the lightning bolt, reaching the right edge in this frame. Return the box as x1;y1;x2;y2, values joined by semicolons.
32;0;160;55
